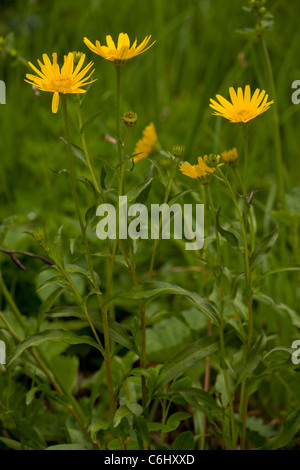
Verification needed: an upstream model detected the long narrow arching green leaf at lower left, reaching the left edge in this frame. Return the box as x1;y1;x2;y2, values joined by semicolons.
7;330;101;367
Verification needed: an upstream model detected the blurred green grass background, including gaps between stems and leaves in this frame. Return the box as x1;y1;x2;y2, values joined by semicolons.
0;0;300;448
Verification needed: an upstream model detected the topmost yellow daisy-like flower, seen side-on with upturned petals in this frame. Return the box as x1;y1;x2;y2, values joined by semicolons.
83;33;155;65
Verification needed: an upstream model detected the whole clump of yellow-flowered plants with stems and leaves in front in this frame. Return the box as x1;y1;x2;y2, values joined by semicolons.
0;0;300;452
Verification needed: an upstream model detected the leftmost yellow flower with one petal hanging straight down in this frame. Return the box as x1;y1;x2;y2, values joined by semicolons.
25;52;95;113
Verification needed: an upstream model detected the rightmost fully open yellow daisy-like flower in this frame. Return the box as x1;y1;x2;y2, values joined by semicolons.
209;85;273;123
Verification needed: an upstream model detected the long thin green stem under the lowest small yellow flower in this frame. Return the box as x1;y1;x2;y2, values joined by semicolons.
206;186;236;449
